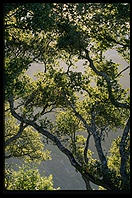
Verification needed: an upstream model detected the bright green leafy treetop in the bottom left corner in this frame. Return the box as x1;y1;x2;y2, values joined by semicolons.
5;166;59;190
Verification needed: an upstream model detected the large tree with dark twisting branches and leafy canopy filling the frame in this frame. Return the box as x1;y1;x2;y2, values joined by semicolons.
4;3;130;191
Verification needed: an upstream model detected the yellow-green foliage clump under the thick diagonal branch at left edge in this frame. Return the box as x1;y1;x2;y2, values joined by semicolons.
5;103;51;163
